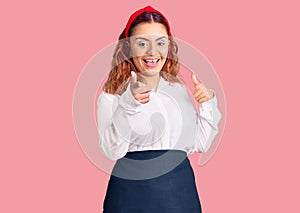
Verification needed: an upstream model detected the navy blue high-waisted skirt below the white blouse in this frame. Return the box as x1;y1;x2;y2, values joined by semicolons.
103;150;202;213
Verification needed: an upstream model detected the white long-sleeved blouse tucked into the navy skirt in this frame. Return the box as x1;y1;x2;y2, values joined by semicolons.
97;77;221;160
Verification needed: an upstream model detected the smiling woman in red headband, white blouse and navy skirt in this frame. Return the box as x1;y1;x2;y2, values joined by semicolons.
97;6;220;213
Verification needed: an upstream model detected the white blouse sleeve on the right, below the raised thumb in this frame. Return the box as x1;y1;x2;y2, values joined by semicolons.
195;90;221;152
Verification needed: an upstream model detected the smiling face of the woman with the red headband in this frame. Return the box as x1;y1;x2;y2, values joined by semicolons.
130;22;169;72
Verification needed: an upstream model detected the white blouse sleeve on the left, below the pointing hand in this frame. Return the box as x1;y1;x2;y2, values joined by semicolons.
97;86;142;160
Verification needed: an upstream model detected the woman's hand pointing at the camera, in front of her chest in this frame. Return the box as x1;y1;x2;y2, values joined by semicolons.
130;71;151;104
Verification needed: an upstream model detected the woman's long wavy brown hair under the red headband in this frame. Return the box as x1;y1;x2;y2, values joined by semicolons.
104;12;180;94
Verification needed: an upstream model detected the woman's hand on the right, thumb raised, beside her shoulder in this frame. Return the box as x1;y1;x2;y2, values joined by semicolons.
192;73;214;104
